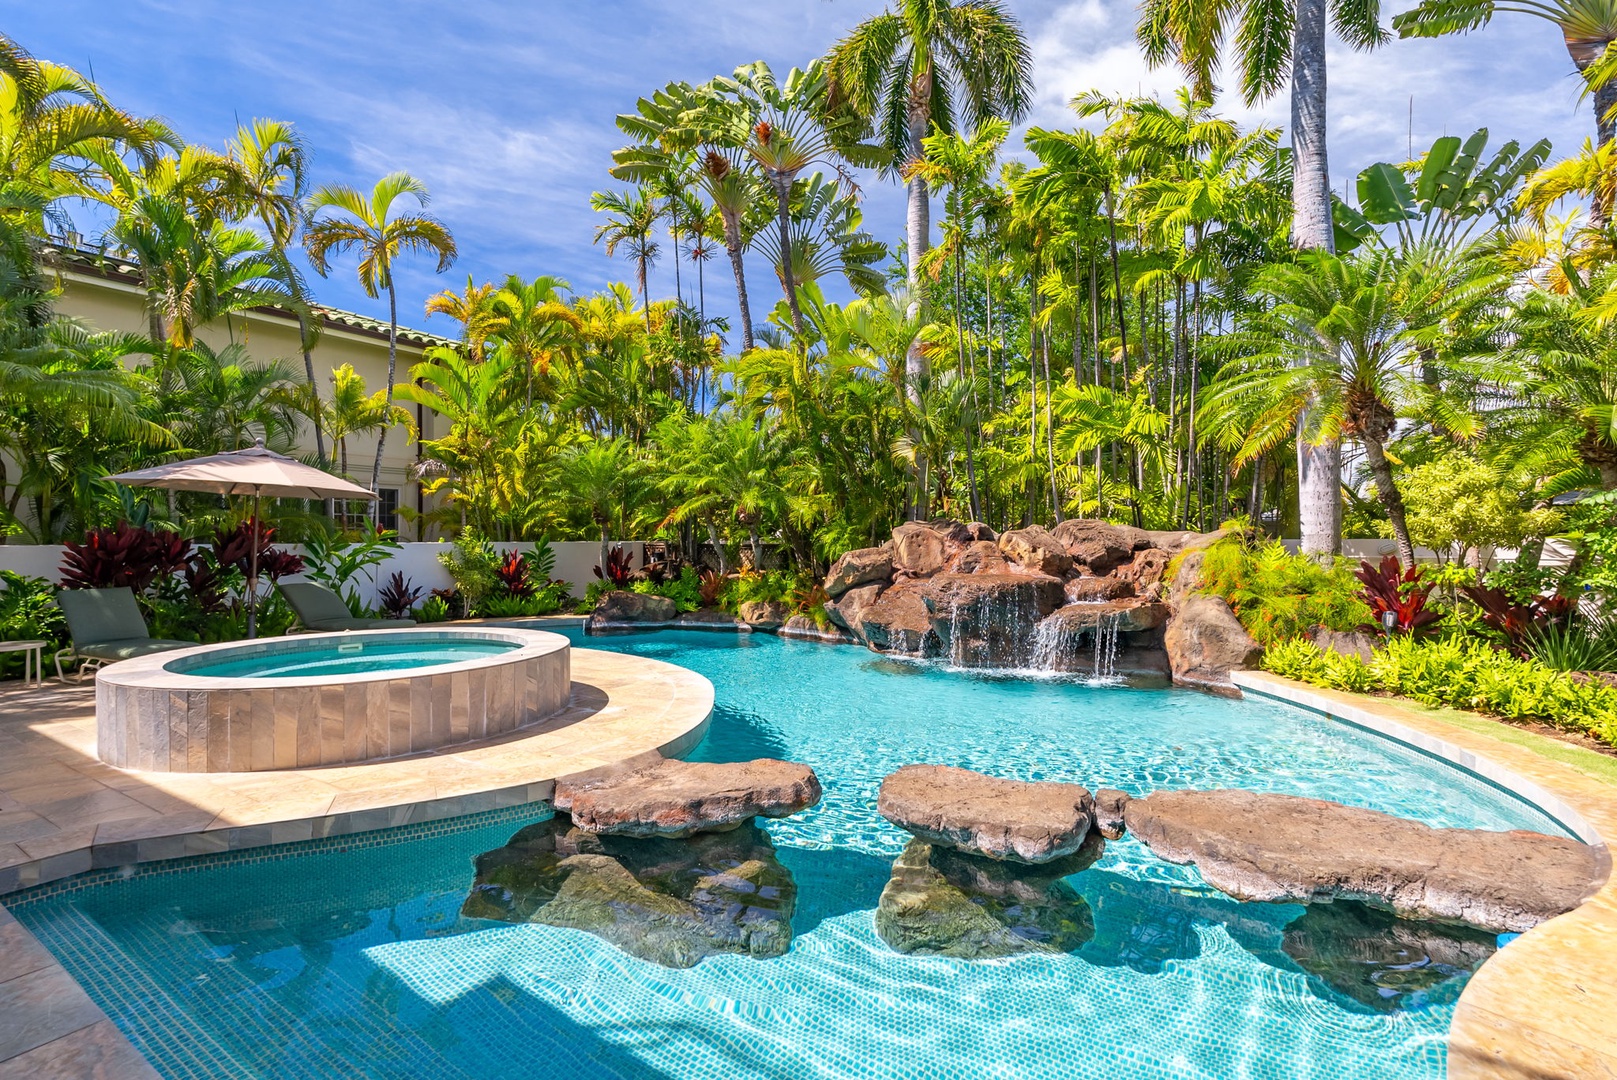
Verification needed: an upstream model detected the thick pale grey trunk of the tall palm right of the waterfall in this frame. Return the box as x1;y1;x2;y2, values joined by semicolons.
1292;0;1342;556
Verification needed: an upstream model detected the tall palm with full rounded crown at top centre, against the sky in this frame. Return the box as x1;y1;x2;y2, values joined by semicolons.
828;0;1033;329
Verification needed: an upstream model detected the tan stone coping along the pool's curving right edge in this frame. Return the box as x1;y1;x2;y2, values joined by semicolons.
1234;671;1617;1080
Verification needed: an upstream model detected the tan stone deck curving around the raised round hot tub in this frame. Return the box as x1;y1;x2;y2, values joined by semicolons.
0;648;713;896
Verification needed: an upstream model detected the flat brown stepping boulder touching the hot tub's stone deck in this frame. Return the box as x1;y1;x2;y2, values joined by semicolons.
551;758;820;837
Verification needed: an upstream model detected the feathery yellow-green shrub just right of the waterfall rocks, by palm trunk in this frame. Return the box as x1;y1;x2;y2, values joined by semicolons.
1201;537;1371;647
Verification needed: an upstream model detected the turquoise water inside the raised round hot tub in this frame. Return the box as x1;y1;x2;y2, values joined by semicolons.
165;632;521;679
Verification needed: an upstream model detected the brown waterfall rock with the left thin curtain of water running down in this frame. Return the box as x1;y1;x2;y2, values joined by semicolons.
922;574;1062;668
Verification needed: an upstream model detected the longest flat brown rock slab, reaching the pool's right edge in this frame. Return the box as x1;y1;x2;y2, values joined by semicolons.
1124;791;1606;931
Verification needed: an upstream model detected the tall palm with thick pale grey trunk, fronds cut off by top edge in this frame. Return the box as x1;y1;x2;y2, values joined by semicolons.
1138;0;1387;556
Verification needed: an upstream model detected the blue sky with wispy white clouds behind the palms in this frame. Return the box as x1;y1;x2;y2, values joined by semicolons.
12;0;1593;341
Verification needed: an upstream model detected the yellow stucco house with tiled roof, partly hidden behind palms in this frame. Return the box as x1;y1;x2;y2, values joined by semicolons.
44;244;454;540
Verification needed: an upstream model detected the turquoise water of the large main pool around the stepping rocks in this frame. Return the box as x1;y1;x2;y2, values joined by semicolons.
13;632;1562;1080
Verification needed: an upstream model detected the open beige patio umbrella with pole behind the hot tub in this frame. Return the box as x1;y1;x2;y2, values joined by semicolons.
107;440;377;637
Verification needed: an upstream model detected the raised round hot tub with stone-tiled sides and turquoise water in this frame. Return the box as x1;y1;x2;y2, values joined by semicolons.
95;627;572;773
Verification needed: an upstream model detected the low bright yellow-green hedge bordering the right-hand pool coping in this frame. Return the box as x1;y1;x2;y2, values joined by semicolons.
1263;635;1617;745
